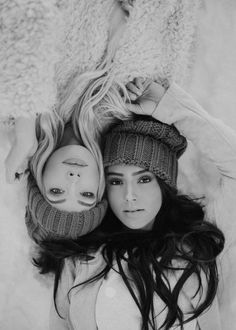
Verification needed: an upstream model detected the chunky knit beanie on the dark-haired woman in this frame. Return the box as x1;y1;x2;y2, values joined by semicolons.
103;117;187;188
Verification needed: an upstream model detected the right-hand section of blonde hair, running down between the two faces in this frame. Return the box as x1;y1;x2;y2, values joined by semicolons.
72;72;131;198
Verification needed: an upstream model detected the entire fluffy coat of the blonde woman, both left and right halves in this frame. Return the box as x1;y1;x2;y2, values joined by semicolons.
0;0;199;121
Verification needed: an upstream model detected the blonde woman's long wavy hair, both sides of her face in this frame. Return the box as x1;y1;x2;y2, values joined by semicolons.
30;69;131;201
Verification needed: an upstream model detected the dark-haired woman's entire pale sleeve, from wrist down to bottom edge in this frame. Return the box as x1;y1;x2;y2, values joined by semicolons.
153;84;236;330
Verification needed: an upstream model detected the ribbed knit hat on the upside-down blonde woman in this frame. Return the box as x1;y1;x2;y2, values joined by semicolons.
25;175;107;242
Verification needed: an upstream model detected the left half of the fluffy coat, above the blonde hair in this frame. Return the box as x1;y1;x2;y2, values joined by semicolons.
0;0;115;118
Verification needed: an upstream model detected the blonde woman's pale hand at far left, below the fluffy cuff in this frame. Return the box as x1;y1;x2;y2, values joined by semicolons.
5;117;38;183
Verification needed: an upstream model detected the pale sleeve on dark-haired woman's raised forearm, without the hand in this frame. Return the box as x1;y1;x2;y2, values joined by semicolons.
152;84;236;179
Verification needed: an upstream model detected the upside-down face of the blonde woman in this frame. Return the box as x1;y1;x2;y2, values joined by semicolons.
43;145;99;212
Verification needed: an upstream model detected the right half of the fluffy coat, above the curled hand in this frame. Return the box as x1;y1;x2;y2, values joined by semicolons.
109;0;199;85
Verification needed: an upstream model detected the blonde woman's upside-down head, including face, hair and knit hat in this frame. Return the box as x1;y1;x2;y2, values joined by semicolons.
22;75;131;243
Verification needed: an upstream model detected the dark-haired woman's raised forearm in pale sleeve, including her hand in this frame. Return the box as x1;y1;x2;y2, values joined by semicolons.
127;78;236;179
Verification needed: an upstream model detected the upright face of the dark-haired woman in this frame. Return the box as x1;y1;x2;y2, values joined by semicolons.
106;165;162;230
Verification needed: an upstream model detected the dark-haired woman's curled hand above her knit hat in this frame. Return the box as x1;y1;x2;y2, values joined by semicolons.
126;78;165;116
